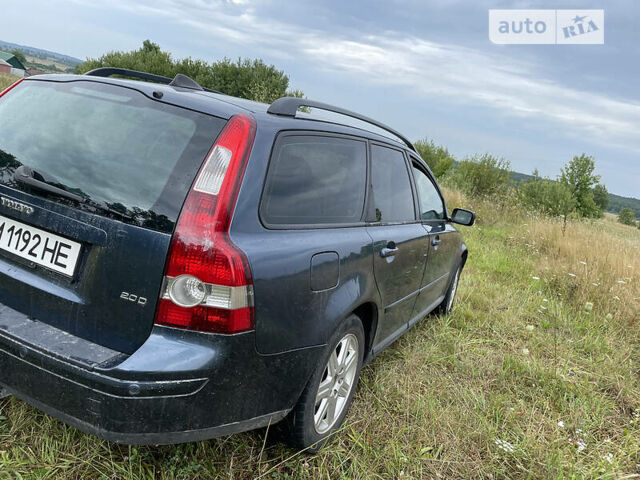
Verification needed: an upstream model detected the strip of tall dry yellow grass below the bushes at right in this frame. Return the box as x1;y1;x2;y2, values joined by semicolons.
444;188;640;323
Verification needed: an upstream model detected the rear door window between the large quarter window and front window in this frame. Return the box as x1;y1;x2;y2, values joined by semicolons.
371;145;415;223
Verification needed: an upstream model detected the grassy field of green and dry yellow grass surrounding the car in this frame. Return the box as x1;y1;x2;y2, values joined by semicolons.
0;191;640;479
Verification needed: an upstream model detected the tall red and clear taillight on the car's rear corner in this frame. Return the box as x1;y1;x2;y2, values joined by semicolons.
155;115;256;333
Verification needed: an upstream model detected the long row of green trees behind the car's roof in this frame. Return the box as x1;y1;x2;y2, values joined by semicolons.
76;40;303;103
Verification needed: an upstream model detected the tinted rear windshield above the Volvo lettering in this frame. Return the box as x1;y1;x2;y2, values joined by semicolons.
0;81;225;232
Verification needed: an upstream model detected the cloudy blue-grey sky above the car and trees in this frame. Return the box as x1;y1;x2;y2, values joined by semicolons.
0;0;640;198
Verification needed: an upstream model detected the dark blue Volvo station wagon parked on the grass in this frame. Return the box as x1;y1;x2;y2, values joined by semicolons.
0;69;474;450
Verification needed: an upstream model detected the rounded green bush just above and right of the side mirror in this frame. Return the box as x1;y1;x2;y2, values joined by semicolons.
452;153;511;196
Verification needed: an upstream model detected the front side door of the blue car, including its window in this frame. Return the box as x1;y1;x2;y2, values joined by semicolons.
411;158;458;318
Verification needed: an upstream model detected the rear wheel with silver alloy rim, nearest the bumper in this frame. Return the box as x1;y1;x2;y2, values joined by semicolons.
282;315;365;453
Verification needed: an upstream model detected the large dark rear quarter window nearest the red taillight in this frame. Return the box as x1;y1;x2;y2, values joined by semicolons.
260;135;367;225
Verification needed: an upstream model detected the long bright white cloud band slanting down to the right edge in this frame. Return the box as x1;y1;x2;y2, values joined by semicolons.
301;33;640;151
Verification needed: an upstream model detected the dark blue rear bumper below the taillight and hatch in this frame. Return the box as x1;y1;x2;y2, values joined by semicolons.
0;310;319;444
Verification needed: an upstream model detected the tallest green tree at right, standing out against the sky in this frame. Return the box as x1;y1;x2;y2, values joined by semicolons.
559;153;603;217
